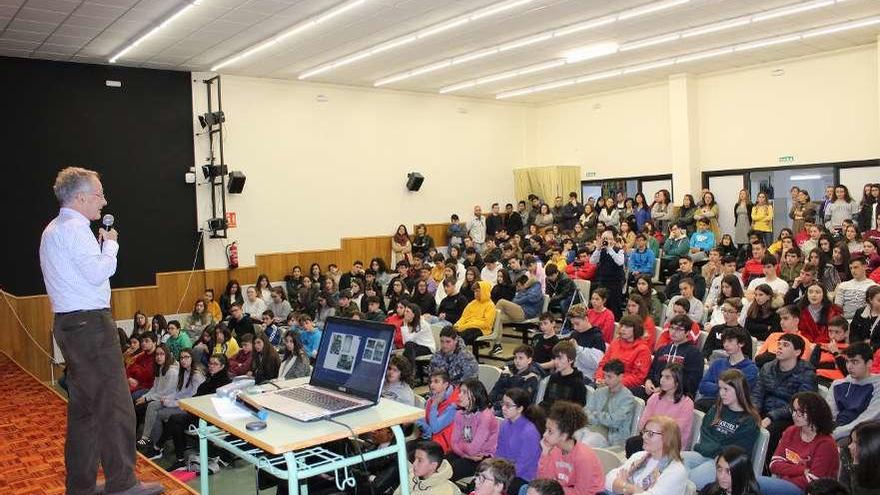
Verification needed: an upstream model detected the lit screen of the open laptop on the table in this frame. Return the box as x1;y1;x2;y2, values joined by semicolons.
309;317;394;401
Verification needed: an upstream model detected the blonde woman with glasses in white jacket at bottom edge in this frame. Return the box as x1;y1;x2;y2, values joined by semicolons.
605;415;688;495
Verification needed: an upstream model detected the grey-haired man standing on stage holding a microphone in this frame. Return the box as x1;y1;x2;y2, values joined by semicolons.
40;167;163;495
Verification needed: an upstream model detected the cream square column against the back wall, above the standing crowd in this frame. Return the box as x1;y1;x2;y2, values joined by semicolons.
669;74;702;203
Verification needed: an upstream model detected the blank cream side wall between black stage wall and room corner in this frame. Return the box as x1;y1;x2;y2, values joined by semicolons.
194;75;528;268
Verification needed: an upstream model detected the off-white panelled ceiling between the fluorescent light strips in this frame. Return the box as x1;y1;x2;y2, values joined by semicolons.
0;0;880;103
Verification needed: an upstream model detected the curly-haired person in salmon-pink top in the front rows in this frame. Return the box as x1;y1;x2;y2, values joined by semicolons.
537;401;604;495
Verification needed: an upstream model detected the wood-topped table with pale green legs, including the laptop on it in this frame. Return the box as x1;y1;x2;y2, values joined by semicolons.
180;318;424;495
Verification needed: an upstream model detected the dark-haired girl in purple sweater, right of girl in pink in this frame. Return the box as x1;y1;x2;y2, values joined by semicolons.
495;388;545;494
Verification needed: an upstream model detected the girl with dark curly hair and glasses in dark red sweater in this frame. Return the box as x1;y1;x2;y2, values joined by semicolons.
758;392;840;495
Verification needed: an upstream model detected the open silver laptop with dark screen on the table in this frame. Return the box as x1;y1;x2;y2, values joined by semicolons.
247;317;394;421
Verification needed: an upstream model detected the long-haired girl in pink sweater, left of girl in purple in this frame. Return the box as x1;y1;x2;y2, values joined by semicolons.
446;378;498;481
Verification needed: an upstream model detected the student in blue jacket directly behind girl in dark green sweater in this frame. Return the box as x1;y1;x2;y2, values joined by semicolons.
696;327;758;412
